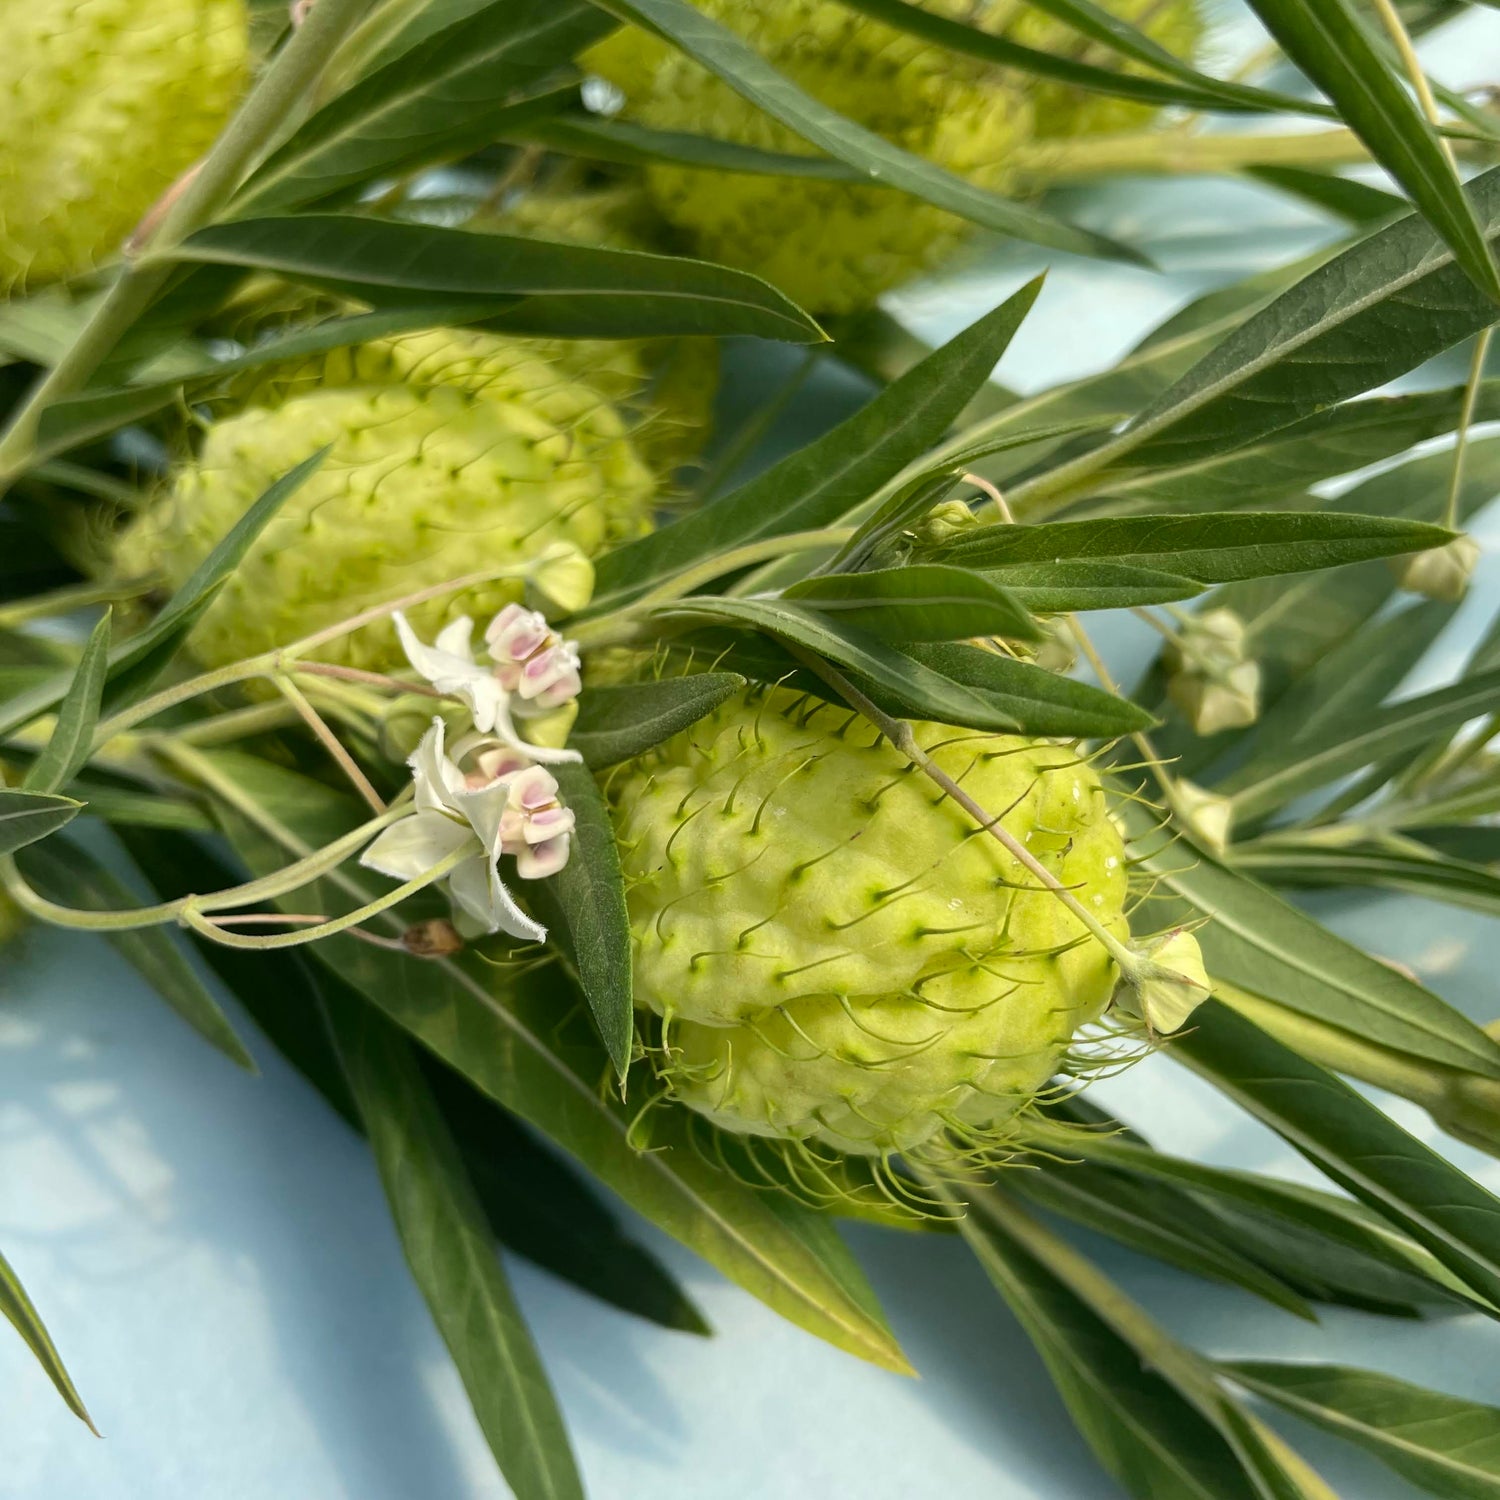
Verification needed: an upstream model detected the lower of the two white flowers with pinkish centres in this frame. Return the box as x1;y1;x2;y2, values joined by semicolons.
360;717;552;942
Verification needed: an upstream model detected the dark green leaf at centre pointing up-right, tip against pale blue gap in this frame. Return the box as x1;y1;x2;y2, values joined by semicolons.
588;302;1044;614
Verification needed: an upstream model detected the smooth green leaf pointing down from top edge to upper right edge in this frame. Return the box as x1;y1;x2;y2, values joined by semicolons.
1250;0;1500;302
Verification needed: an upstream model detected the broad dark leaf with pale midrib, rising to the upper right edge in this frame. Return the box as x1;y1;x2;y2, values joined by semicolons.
1116;168;1500;464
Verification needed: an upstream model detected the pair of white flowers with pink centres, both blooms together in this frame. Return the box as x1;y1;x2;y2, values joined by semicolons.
360;605;582;942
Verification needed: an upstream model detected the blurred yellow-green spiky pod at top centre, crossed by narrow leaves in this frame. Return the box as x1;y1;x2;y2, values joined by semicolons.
585;0;1031;312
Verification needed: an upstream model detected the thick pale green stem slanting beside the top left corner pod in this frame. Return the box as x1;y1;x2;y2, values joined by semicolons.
0;0;369;488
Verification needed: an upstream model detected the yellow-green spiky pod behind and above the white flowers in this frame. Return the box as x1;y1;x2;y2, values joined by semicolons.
116;330;656;669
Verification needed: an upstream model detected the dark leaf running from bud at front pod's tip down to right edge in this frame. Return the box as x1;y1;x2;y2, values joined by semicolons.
1170;1001;1500;1304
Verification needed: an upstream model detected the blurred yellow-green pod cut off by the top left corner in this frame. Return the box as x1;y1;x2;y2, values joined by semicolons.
0;0;249;291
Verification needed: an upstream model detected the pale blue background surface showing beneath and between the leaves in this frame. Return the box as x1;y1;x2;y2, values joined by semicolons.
0;11;1500;1500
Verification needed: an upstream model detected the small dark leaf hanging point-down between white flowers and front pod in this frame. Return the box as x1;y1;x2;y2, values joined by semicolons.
534;765;635;1079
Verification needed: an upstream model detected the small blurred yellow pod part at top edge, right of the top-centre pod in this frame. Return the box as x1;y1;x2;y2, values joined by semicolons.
1010;0;1203;138
